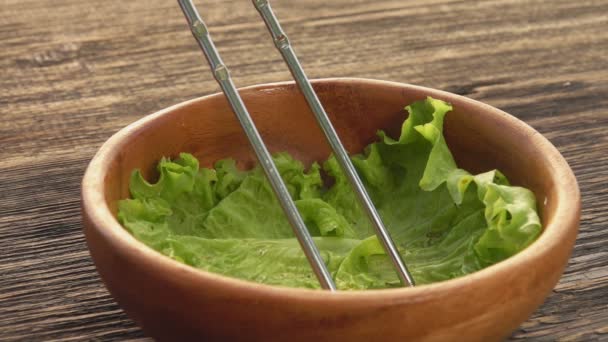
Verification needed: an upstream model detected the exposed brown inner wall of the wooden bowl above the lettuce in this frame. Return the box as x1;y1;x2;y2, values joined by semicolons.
104;80;555;225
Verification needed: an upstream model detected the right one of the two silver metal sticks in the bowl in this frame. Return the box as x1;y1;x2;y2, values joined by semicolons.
253;0;414;286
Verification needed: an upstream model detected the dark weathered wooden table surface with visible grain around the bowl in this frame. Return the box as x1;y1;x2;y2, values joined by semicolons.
0;0;608;341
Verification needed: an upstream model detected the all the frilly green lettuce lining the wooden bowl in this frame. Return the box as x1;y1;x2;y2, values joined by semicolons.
118;98;542;290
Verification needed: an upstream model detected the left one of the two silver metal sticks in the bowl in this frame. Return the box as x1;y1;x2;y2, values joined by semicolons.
178;0;336;291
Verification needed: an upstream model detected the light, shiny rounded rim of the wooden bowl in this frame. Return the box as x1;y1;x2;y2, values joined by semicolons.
81;78;580;303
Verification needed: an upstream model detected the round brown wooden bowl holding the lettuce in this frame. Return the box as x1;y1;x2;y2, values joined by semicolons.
82;79;580;341
